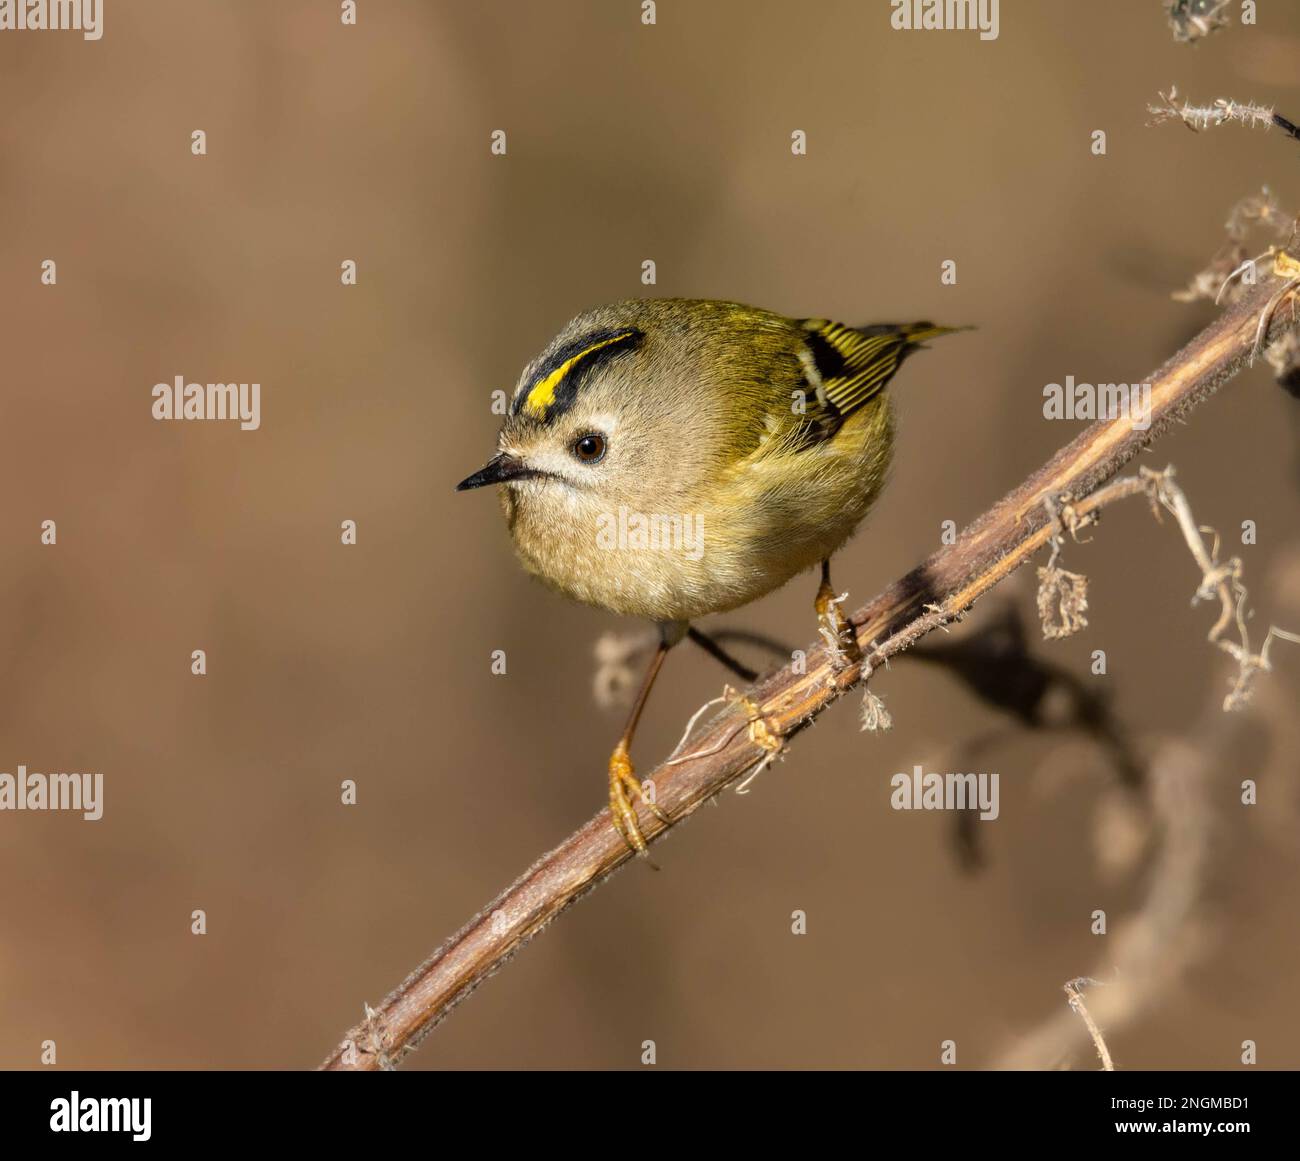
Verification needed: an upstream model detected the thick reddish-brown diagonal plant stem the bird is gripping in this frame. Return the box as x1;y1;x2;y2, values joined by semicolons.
321;267;1295;1070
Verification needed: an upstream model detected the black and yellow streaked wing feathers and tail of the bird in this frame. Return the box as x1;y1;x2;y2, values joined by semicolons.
802;319;959;434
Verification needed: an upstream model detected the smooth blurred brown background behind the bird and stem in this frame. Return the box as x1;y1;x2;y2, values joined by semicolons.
0;0;1300;1069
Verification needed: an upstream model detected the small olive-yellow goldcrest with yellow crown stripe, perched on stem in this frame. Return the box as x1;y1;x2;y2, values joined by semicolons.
458;299;962;854
